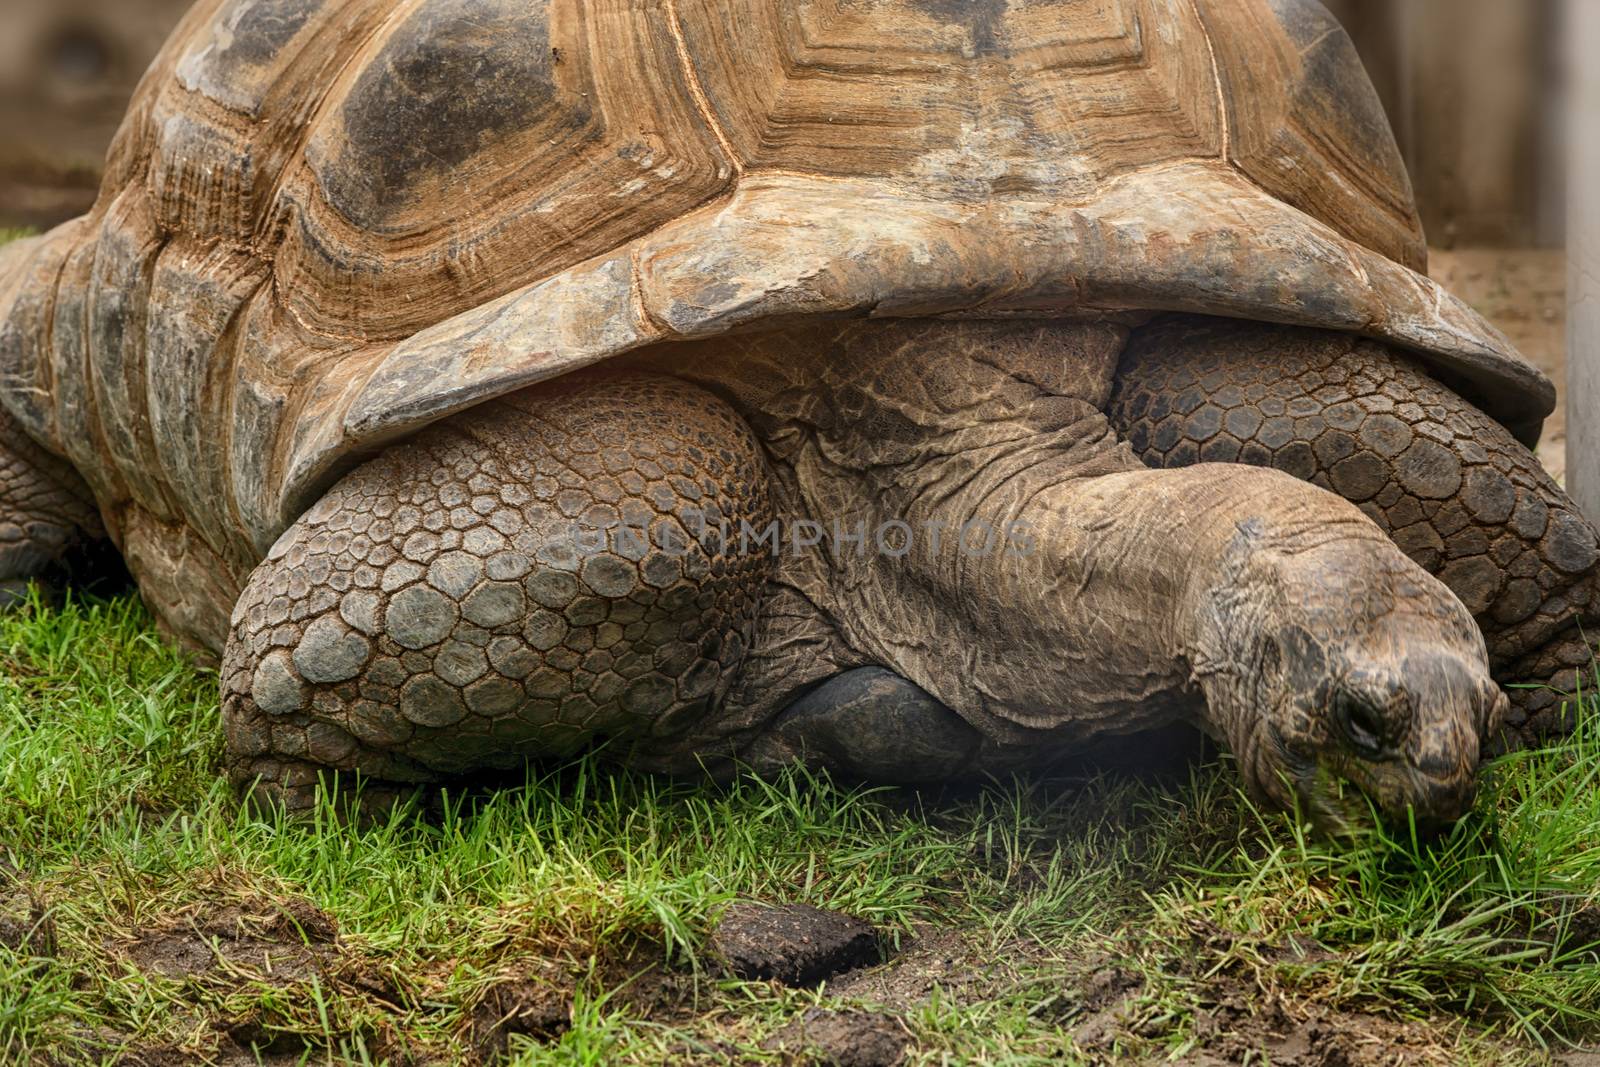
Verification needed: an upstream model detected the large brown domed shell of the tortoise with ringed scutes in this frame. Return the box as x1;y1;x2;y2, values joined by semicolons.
0;0;1554;568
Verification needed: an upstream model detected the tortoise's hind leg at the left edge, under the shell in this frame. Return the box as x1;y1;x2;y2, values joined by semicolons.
0;408;109;606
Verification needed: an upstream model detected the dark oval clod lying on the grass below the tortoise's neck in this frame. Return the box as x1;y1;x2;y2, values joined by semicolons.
712;904;878;985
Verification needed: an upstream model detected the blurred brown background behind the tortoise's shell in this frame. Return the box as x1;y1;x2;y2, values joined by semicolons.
0;0;1574;472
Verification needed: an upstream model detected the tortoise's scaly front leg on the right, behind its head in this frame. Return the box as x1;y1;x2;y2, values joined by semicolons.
1112;317;1600;741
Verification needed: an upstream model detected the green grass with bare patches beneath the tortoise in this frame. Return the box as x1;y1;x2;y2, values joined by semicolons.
0;588;1600;1064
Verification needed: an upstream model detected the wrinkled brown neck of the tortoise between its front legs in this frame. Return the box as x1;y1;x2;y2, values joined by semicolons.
643;316;1267;744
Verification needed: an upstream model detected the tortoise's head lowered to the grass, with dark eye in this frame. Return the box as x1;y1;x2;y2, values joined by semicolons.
1195;522;1507;837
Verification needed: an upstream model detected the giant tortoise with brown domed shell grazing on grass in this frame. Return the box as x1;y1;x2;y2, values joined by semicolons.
0;0;1600;830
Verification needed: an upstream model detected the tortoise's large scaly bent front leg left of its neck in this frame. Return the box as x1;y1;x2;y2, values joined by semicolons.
222;374;771;809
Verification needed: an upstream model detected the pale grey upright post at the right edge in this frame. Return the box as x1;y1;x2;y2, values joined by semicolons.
1565;0;1600;523
